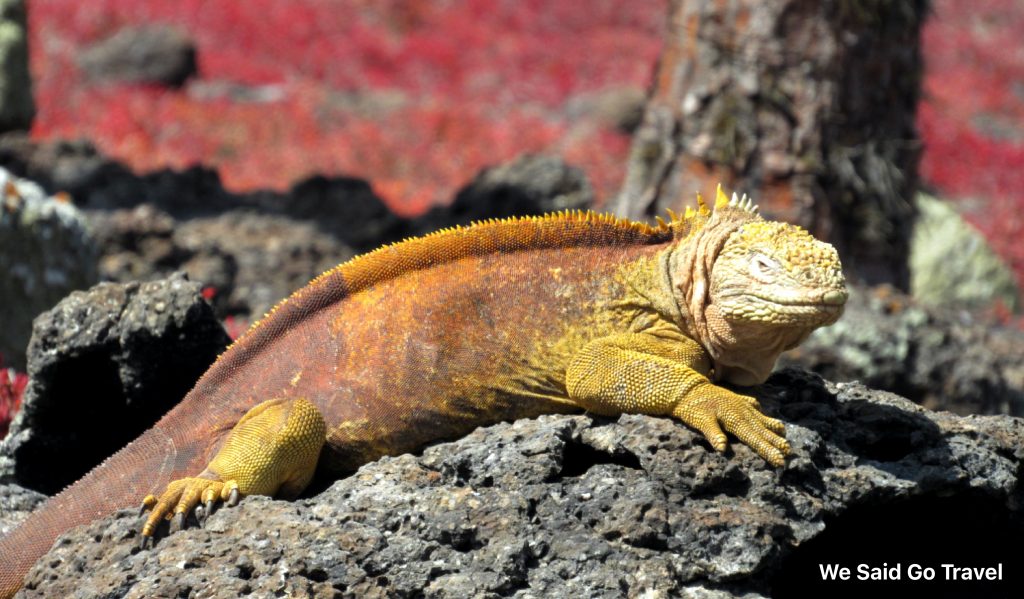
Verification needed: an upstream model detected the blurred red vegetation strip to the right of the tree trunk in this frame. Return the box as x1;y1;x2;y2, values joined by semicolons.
919;0;1024;285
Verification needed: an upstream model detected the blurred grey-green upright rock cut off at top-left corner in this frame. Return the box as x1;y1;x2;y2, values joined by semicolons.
0;0;36;131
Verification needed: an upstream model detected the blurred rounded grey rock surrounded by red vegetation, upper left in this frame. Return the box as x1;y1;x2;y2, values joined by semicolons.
79;25;198;87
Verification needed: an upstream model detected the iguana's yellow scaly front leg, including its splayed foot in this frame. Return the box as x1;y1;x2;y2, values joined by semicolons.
565;330;790;466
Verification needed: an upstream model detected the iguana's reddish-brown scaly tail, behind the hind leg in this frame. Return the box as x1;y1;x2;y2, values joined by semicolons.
0;410;219;599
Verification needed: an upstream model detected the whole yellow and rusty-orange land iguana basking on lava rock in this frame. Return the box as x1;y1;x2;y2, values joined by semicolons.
0;187;847;597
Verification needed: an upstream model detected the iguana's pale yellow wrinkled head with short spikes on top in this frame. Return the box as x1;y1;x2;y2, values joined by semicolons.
672;187;847;385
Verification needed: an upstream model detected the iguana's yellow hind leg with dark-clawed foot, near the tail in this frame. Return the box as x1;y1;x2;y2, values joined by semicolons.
142;398;327;545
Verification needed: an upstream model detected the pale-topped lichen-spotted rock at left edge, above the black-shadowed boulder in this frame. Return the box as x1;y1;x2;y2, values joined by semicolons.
0;168;97;370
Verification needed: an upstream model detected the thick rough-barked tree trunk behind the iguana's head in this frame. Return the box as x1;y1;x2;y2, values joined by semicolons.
611;0;928;289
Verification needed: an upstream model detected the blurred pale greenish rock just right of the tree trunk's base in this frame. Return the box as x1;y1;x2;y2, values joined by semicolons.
910;194;1021;310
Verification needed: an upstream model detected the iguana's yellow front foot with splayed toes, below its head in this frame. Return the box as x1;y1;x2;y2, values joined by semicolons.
673;384;791;466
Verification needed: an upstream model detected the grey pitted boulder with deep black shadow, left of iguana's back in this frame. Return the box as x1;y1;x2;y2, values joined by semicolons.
0;274;229;494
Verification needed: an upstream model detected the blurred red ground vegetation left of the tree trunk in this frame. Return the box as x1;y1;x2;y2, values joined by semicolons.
30;0;666;213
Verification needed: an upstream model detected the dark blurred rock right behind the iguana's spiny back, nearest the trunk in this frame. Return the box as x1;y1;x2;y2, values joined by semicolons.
413;155;594;232
